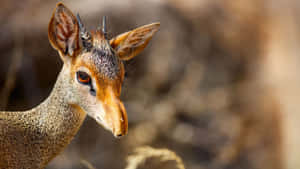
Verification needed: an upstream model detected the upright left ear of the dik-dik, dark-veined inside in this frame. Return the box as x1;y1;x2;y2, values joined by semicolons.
48;2;80;61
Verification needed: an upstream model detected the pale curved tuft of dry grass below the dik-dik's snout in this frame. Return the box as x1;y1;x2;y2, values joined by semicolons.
125;146;185;169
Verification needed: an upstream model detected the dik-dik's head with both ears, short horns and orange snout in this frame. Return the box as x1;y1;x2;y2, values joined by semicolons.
48;3;159;136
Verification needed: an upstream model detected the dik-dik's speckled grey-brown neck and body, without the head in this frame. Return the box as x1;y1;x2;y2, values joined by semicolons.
0;65;86;168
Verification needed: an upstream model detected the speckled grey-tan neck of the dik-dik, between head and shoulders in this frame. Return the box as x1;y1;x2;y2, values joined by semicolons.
30;66;86;142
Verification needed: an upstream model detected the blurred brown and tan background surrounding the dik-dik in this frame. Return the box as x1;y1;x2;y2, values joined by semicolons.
0;0;300;169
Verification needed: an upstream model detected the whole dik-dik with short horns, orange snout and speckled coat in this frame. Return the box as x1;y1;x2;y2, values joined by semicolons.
0;3;160;169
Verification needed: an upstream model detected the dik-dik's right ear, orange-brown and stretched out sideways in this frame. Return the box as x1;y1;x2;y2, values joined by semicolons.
110;23;160;60
